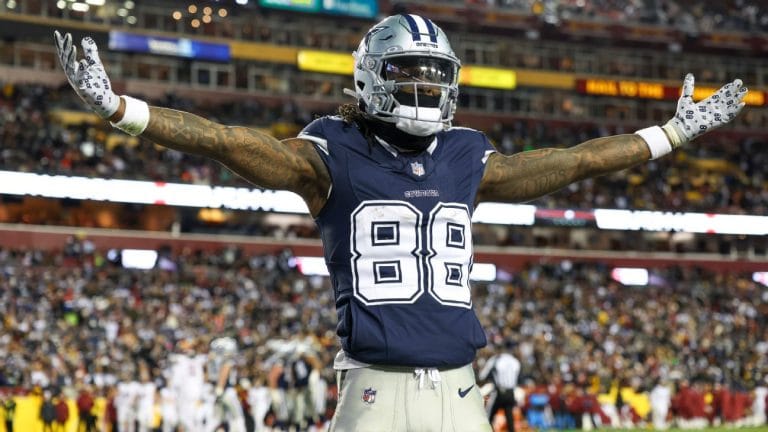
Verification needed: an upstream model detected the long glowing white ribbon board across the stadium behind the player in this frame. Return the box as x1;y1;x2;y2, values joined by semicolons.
0;171;768;235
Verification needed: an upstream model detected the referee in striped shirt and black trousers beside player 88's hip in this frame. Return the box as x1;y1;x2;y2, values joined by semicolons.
478;344;520;432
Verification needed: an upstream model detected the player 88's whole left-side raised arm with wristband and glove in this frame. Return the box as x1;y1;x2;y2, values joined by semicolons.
55;32;330;215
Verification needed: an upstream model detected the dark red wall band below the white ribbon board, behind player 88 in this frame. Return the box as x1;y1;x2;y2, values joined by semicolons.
0;224;768;271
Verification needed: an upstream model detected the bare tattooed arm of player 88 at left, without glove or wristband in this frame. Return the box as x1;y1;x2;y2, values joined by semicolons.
110;102;331;215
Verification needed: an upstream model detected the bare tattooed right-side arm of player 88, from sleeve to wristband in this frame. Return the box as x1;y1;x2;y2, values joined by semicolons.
478;134;651;202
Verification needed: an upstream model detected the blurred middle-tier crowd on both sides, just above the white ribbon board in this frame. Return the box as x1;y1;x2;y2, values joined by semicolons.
0;81;768;215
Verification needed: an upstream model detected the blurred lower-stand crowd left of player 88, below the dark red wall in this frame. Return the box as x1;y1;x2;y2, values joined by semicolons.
0;239;336;430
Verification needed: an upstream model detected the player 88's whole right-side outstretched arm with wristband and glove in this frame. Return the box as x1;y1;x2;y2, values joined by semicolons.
478;74;747;202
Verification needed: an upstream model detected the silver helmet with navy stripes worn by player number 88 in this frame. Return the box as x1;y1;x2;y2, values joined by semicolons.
348;14;461;136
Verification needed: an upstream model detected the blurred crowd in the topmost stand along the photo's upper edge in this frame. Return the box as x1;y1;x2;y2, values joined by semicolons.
26;0;768;49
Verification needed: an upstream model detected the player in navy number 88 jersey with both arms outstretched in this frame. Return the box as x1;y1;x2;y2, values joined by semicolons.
55;14;747;431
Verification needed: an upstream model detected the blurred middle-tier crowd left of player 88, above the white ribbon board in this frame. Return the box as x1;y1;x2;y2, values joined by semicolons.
0;84;309;185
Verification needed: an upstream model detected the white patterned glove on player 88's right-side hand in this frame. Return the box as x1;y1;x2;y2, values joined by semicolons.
661;73;747;149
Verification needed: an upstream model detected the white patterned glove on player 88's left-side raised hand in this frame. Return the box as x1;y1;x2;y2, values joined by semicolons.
54;31;120;119
